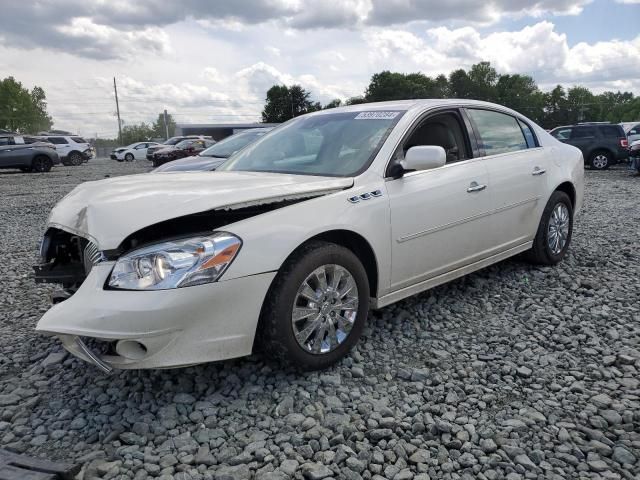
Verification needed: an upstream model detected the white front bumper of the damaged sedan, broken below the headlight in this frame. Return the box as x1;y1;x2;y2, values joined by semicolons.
36;261;275;372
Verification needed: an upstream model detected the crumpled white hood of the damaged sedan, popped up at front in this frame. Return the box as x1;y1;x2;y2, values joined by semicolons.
48;172;353;250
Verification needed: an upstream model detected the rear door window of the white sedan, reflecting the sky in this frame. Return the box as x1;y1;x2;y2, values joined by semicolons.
468;109;527;155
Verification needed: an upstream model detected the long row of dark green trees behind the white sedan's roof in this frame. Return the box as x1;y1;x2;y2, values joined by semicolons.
262;62;640;128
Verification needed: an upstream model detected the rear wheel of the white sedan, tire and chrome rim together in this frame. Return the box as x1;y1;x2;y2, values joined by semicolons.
527;190;573;265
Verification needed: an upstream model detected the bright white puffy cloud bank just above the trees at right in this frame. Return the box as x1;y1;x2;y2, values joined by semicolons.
367;21;640;90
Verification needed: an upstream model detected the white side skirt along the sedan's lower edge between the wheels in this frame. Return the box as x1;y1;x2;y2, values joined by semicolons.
370;241;532;310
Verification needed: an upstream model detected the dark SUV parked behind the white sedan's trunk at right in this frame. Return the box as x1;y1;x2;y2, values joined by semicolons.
549;122;629;170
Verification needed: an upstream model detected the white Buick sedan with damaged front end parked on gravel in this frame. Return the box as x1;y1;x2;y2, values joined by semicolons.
35;100;584;371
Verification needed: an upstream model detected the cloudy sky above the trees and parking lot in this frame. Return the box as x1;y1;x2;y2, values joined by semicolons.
0;0;640;137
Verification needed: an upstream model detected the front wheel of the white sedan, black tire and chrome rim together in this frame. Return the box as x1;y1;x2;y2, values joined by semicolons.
260;242;369;370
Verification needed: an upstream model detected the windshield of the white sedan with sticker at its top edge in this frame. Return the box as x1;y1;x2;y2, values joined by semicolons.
219;110;404;177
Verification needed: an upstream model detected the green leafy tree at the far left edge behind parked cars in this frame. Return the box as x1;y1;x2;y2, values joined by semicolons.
0;77;53;133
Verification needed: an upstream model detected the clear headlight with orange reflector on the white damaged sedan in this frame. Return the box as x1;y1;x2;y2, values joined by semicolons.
109;232;242;290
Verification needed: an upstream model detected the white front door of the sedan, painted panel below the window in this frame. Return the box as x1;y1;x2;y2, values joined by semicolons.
386;159;494;291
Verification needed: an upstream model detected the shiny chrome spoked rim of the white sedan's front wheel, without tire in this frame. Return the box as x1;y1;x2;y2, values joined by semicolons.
291;265;359;354
